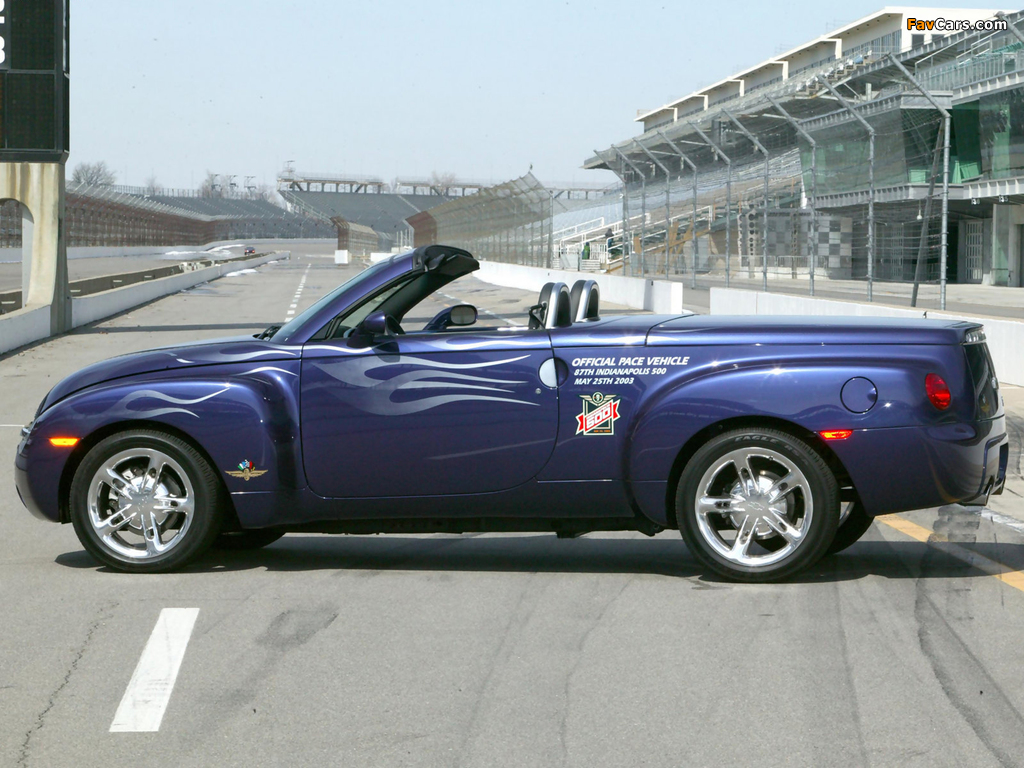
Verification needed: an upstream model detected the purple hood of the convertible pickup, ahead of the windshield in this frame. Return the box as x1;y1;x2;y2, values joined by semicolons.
36;336;300;416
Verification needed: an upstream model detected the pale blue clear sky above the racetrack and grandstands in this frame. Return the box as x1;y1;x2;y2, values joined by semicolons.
68;0;1015;187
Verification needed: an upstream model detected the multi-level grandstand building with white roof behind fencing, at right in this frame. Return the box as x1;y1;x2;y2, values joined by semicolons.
584;7;1024;286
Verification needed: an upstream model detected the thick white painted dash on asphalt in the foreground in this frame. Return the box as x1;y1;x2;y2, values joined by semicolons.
111;608;199;733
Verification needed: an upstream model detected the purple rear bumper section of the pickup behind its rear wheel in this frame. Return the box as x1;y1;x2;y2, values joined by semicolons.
829;417;1010;515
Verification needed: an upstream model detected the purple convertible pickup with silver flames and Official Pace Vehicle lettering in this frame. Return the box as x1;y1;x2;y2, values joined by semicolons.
15;246;1009;581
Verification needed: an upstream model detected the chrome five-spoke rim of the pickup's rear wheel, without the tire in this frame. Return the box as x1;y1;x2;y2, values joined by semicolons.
693;445;814;567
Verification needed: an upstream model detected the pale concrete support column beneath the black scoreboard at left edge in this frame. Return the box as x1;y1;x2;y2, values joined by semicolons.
0;163;72;334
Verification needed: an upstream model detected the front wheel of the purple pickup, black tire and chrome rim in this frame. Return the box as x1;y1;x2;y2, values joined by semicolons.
70;429;223;573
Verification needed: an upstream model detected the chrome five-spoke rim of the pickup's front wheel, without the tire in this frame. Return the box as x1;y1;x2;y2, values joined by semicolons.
86;447;196;561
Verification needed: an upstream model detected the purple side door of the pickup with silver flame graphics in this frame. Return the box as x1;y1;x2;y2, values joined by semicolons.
301;331;558;499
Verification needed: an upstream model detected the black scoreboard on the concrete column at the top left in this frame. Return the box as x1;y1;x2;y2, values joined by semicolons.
0;0;70;163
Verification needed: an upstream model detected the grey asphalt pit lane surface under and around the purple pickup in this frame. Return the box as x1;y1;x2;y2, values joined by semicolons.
0;249;1024;766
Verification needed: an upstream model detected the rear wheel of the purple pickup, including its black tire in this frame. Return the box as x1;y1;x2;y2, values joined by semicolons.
676;427;840;582
